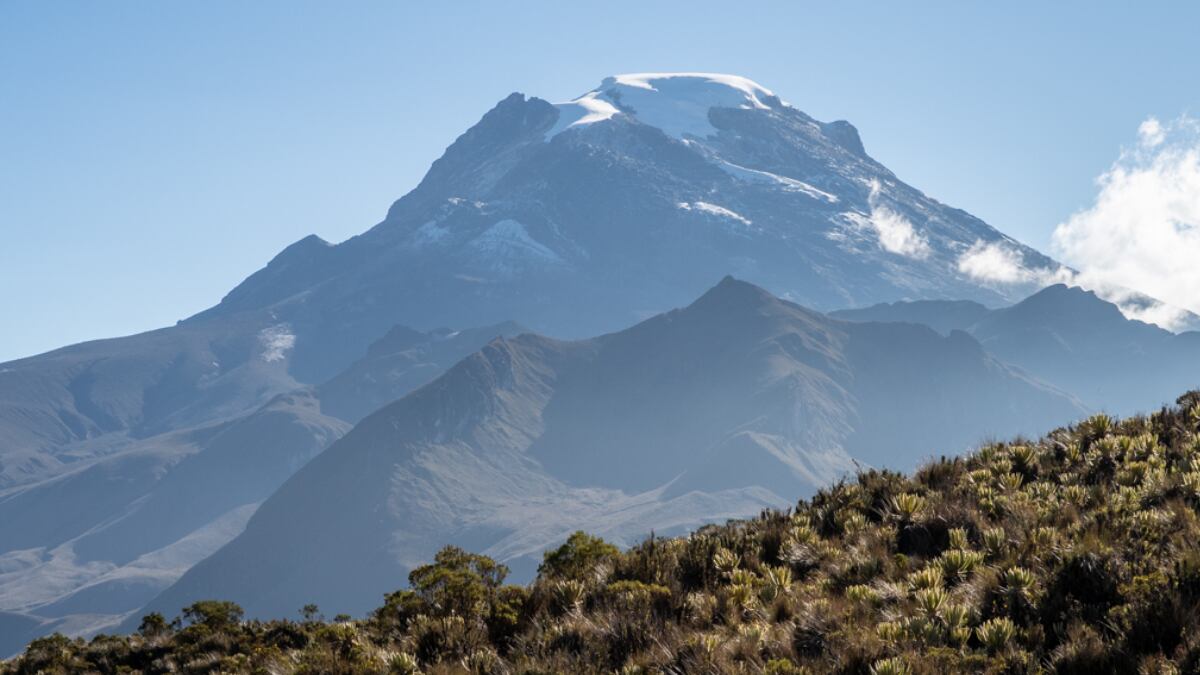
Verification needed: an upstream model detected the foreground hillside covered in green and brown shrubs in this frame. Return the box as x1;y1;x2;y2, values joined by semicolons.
7;392;1200;675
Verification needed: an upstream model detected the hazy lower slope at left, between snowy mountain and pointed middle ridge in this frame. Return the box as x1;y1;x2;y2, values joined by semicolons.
0;323;511;651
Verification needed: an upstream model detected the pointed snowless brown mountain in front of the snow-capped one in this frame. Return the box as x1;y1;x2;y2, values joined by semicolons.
136;279;1082;616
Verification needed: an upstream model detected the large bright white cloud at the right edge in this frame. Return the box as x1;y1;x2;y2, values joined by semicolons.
1052;118;1200;328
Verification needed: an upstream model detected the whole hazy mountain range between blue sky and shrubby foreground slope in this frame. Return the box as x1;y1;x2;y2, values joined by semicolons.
0;74;1196;651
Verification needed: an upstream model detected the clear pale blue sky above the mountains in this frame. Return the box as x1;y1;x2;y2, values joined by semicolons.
0;0;1200;360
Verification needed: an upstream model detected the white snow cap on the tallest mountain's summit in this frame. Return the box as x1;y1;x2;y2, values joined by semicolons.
547;72;785;138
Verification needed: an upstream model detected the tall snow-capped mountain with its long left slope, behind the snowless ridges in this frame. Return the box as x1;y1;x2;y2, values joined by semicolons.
0;74;1057;488
